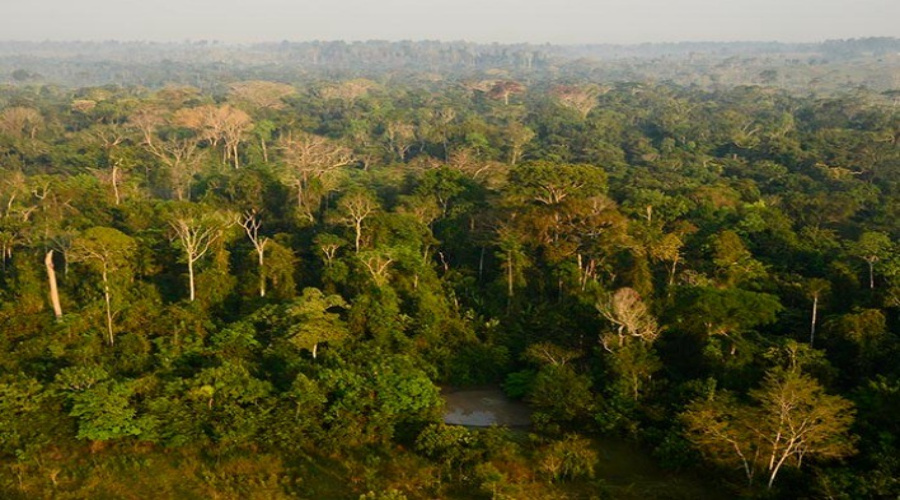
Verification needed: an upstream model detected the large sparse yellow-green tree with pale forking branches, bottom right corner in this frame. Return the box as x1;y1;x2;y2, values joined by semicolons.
682;367;854;489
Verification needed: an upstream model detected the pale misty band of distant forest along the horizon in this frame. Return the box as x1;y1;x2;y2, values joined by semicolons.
0;37;900;93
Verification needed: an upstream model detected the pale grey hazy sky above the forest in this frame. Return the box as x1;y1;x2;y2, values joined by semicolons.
0;0;900;43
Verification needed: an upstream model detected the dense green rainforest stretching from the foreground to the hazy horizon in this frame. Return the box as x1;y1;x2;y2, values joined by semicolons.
0;40;900;499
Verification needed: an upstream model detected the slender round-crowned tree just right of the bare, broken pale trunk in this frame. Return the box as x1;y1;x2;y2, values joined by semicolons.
71;227;137;345
